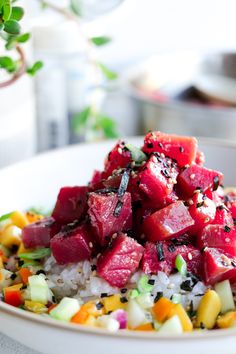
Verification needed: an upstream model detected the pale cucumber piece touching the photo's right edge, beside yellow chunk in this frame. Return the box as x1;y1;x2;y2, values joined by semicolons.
215;280;235;313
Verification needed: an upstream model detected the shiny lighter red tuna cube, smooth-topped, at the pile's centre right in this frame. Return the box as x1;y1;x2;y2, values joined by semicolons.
143;201;194;242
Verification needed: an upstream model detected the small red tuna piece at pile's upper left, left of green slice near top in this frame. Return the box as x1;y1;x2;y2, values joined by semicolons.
104;141;131;178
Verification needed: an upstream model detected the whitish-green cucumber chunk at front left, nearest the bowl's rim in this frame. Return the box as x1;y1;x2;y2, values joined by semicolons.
50;297;80;322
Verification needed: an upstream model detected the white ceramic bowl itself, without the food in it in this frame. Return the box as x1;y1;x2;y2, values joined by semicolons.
0;138;236;354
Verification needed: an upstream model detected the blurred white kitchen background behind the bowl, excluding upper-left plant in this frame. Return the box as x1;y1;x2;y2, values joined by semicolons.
0;0;236;167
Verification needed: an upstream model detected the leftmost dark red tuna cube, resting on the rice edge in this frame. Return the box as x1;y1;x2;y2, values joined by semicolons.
22;217;59;248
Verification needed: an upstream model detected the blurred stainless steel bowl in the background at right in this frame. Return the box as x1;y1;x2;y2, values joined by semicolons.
126;52;236;141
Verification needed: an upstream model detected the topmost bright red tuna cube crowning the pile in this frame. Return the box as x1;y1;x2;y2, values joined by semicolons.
143;131;197;167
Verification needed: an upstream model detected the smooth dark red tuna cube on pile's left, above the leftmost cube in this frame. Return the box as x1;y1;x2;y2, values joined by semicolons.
52;187;88;224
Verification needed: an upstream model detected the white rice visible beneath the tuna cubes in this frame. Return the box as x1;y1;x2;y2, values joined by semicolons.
44;256;206;310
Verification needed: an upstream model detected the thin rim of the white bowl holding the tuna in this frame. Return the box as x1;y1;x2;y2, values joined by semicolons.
0;136;236;341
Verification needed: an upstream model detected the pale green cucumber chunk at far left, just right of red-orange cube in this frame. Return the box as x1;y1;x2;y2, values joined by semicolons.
29;274;52;305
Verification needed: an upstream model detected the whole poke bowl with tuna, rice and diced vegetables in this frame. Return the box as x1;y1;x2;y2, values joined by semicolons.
0;132;236;354
